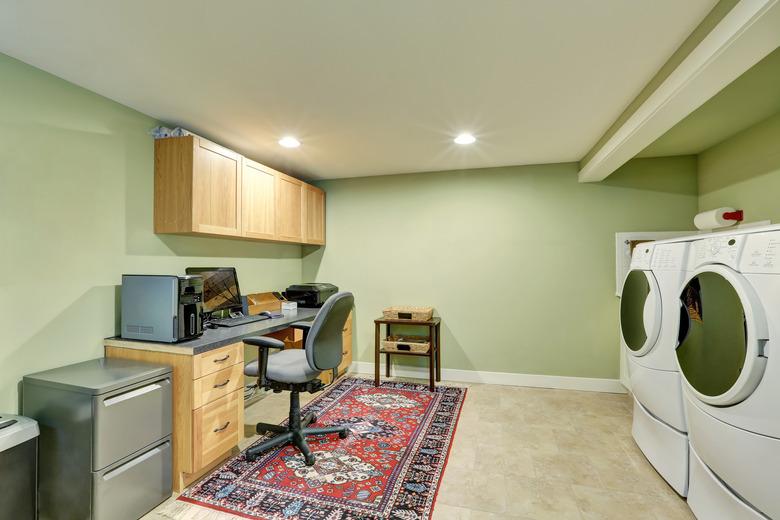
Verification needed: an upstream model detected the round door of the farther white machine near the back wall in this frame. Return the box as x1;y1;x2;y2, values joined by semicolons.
620;269;661;356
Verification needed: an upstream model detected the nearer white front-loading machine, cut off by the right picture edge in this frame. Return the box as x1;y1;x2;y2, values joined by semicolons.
676;226;780;520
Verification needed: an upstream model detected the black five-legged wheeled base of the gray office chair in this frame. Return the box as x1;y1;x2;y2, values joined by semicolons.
245;391;349;466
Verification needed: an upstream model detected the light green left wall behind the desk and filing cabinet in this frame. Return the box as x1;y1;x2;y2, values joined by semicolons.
0;54;301;412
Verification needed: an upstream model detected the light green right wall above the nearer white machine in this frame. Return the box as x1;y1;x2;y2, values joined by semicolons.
699;113;780;222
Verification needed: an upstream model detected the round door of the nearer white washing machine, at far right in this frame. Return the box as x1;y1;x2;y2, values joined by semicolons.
677;265;768;406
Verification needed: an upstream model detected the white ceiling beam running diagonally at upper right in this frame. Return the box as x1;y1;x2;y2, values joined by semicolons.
579;0;780;182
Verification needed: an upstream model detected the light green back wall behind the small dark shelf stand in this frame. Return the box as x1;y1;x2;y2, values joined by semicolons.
303;157;697;378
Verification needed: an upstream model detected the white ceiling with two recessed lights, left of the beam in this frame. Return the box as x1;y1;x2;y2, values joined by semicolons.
0;0;716;178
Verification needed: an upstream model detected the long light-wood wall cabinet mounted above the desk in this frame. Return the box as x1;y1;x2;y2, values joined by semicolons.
154;135;325;245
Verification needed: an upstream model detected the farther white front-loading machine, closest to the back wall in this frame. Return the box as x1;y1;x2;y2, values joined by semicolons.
620;241;688;496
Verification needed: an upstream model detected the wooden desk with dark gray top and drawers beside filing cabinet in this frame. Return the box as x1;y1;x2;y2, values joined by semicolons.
104;309;317;492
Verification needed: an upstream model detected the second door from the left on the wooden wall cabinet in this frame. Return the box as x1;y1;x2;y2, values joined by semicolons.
241;158;276;239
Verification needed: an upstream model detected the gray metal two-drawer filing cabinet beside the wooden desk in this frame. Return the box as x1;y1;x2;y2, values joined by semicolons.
22;358;172;520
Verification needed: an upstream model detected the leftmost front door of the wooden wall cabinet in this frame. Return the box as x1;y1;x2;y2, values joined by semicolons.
192;139;241;236
